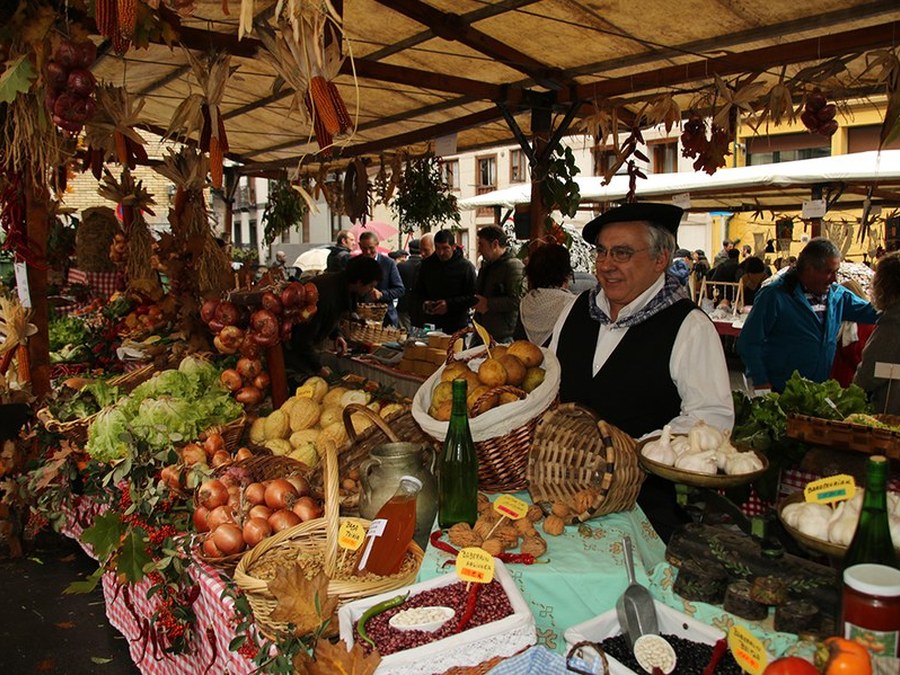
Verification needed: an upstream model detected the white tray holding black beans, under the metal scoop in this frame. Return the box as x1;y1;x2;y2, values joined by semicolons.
565;600;725;675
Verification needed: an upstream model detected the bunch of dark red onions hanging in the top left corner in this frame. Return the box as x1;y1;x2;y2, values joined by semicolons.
44;39;97;133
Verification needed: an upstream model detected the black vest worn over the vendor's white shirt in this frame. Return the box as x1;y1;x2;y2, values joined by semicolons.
556;291;697;437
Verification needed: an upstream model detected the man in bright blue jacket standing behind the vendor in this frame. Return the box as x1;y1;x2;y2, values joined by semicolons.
737;237;877;392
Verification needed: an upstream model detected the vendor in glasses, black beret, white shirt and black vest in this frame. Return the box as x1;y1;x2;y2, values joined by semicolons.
550;203;734;541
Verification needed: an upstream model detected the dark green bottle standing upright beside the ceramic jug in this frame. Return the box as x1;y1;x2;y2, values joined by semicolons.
438;380;478;529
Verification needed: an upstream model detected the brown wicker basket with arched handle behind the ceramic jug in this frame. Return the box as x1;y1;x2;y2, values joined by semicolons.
338;403;437;515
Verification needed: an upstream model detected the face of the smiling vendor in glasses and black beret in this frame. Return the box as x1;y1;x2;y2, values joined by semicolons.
597;222;669;313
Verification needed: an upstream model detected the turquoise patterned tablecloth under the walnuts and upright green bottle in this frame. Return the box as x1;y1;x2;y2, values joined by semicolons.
419;502;665;654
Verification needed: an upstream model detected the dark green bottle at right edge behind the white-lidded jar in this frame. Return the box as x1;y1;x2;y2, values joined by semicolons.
844;455;897;569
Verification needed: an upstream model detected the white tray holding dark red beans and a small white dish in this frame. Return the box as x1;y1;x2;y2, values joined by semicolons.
338;559;537;675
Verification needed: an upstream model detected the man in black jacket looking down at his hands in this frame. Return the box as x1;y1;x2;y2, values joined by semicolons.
412;230;475;334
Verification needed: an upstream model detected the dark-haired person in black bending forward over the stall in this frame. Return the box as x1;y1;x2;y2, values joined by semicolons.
284;256;381;382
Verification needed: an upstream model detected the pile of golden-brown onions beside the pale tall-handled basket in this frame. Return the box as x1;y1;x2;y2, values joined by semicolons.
192;473;322;558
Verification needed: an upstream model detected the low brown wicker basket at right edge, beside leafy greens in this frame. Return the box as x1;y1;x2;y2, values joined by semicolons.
787;415;900;459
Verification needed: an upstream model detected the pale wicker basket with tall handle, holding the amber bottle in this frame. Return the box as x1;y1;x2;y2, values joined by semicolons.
234;430;425;638
